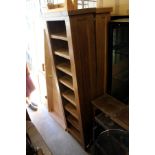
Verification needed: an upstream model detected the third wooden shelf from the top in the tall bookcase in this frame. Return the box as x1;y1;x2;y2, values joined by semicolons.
56;63;72;76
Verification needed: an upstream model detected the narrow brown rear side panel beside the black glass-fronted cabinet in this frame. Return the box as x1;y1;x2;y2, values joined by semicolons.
96;13;110;96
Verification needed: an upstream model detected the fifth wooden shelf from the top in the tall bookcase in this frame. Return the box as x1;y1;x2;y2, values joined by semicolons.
62;90;76;107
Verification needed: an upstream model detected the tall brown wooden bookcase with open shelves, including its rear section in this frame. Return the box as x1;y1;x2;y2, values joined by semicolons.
45;8;112;148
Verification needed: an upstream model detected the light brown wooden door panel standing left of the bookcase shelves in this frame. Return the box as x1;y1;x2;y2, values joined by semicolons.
45;30;66;128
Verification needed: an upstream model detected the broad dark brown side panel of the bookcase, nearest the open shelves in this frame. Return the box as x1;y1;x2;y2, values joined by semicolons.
70;14;96;146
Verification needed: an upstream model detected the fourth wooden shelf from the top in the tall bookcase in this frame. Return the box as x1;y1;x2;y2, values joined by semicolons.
59;76;74;90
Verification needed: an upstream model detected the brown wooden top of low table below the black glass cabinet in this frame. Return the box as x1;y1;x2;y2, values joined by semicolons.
92;94;129;130
